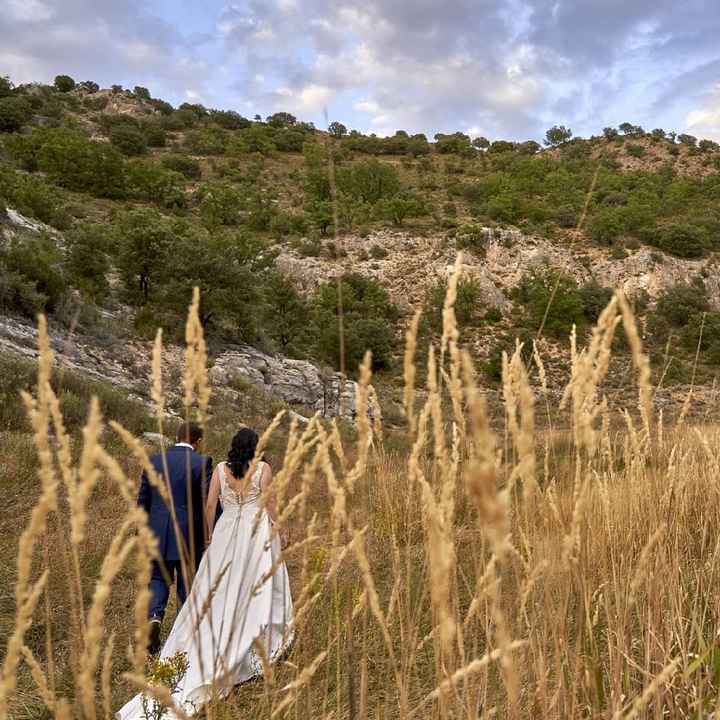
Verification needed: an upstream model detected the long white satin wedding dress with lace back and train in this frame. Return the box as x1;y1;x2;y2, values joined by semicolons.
116;463;293;720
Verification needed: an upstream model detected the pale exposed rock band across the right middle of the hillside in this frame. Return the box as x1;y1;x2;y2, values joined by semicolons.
277;228;720;309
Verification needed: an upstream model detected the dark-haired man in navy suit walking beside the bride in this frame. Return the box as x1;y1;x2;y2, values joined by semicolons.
137;423;212;654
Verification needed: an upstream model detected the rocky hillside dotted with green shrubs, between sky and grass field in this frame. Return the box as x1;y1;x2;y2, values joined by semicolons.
0;78;720;415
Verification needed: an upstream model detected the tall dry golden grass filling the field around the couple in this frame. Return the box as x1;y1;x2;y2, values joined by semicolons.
0;260;720;720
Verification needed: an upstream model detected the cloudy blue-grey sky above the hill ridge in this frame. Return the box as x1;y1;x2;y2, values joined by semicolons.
0;0;720;141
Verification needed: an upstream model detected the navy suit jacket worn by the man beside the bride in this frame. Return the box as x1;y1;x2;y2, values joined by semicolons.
137;445;212;568
